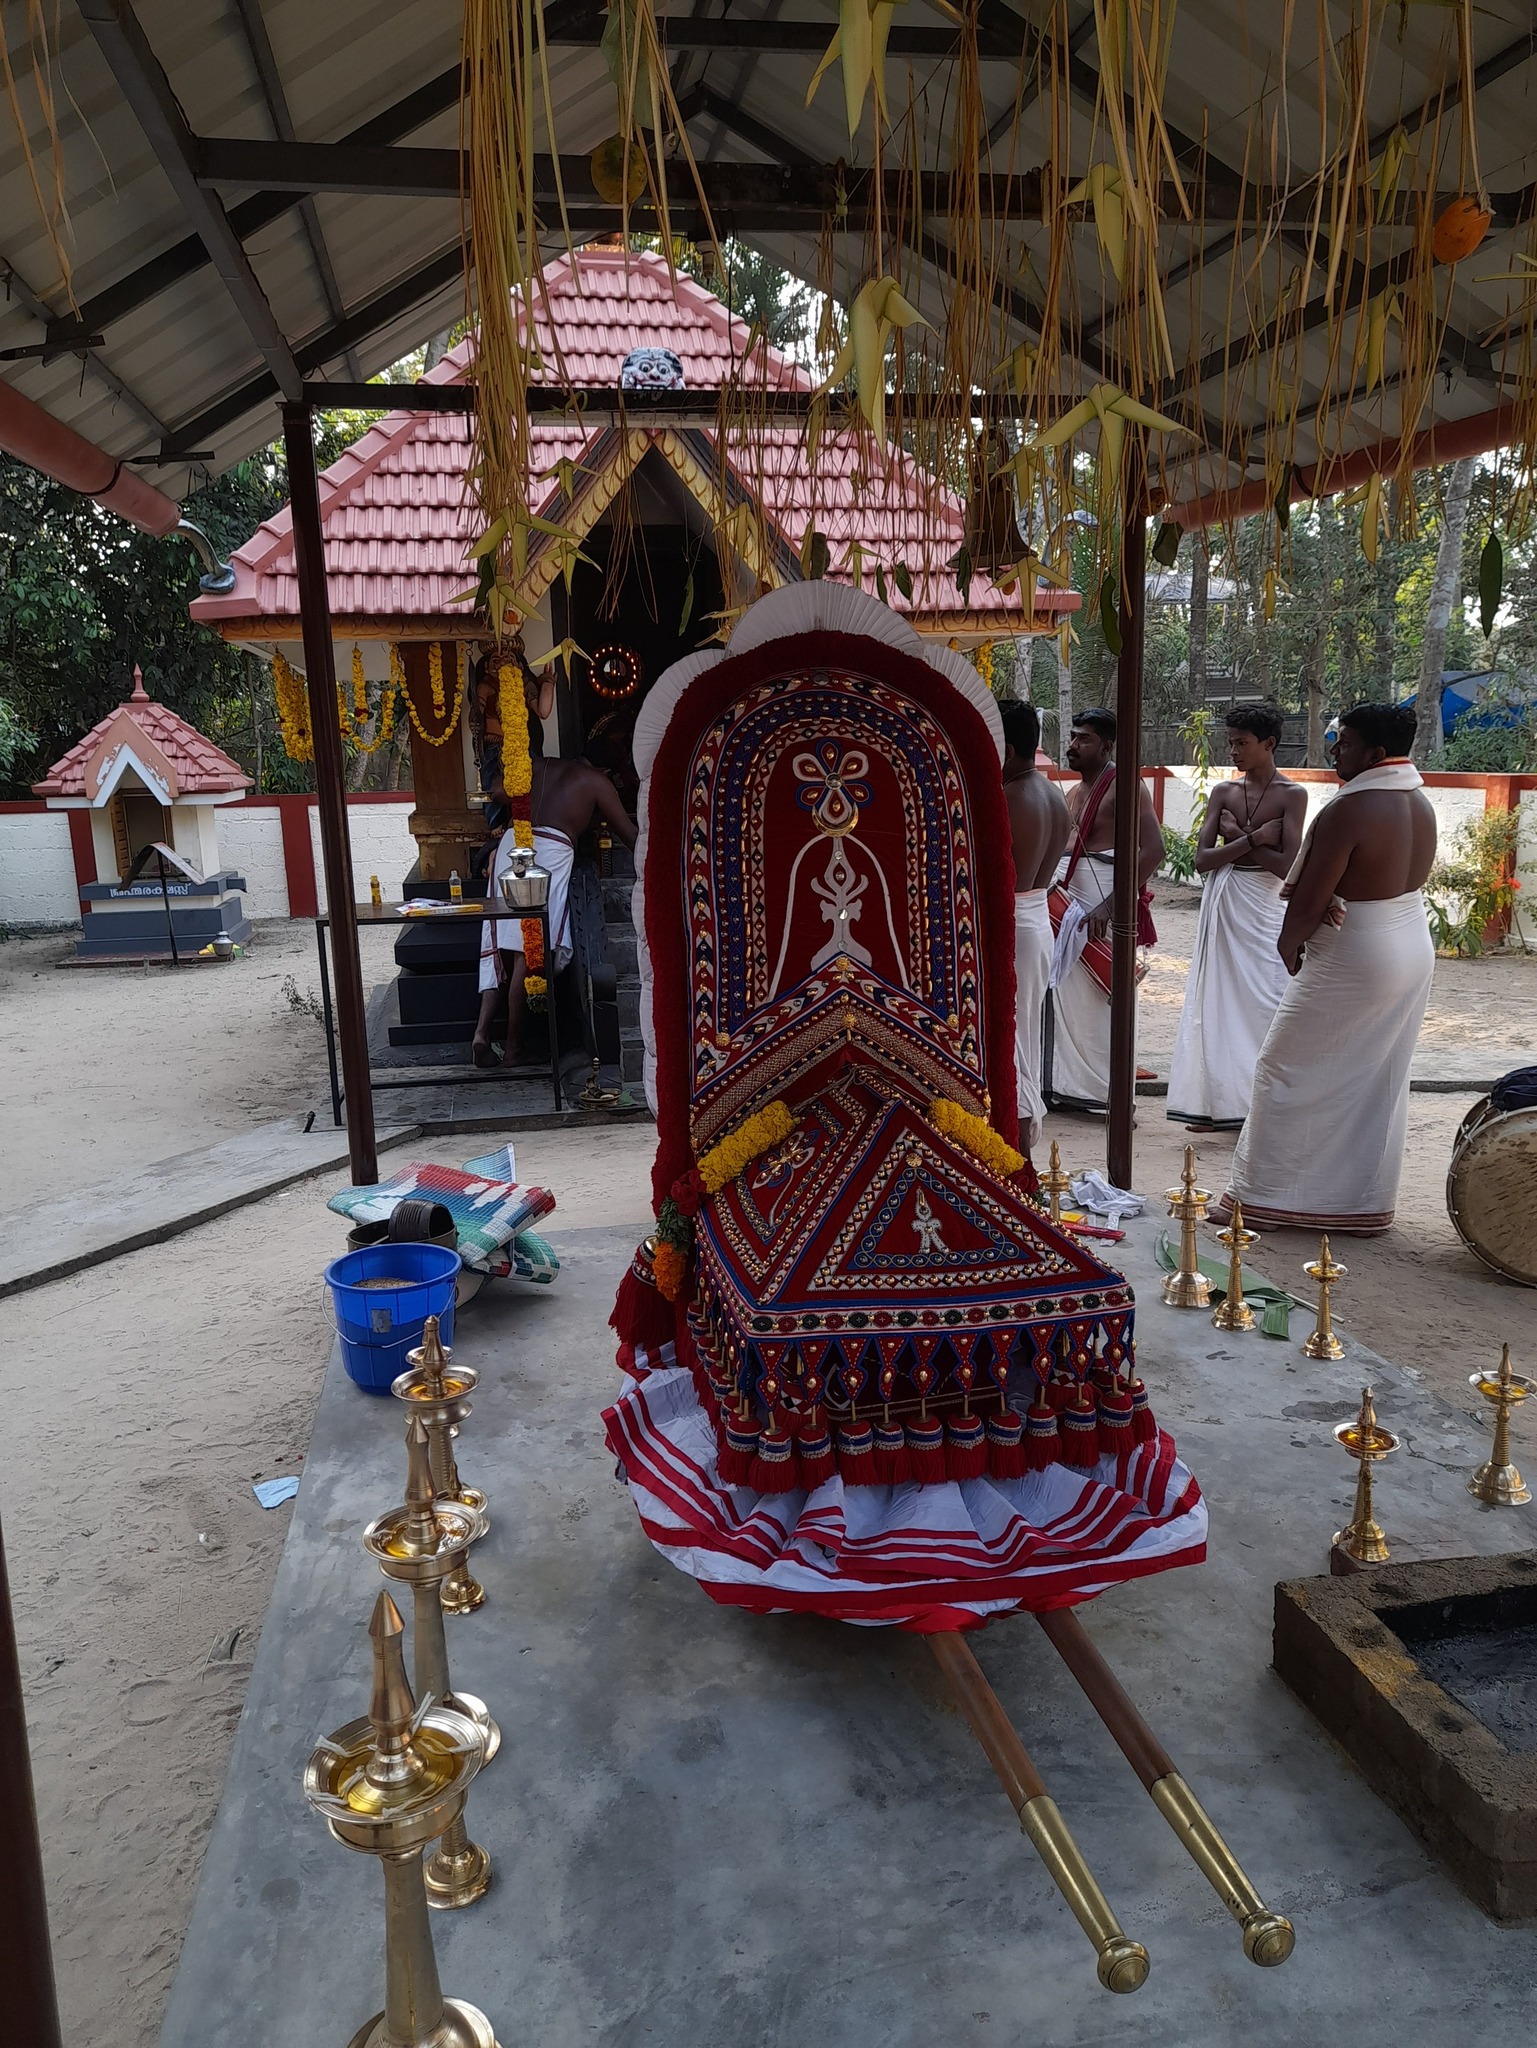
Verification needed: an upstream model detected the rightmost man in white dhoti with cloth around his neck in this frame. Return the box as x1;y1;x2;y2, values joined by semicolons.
1217;705;1437;1237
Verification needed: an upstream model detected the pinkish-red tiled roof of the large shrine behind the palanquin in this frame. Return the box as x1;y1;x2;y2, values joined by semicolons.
193;248;1078;629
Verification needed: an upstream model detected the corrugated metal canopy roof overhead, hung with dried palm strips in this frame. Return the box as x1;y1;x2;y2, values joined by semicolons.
0;0;1537;507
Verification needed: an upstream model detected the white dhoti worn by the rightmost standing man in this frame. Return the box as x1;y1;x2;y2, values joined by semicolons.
1226;889;1435;1235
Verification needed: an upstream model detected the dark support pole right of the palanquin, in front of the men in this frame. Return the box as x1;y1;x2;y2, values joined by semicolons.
1107;448;1148;1188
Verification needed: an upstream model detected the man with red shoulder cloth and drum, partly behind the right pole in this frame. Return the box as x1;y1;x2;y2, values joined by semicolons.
1041;711;1164;1112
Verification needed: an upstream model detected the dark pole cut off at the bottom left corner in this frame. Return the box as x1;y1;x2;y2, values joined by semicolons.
0;1507;64;2048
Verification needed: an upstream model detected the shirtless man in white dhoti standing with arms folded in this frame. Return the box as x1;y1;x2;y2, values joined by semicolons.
1168;705;1307;1130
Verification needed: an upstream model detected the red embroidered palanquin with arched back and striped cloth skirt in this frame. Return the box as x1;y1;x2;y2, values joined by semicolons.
605;584;1205;1630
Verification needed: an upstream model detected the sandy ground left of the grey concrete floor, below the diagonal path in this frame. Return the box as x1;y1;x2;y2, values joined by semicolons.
0;1126;656;2048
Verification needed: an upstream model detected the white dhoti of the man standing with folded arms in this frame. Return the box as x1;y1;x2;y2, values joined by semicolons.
1168;866;1289;1124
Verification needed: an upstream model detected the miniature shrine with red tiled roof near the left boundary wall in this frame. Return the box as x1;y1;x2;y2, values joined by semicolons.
33;666;250;961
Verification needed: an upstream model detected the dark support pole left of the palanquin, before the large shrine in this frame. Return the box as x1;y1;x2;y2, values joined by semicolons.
283;406;379;1188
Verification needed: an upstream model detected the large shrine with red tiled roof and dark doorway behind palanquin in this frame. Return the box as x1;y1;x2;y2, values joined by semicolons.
193;244;1080;893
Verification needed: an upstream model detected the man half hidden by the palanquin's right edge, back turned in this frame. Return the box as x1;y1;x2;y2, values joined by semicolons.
1002;702;1072;1153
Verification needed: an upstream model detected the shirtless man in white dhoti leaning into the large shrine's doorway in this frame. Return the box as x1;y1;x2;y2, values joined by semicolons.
471;705;635;1067
